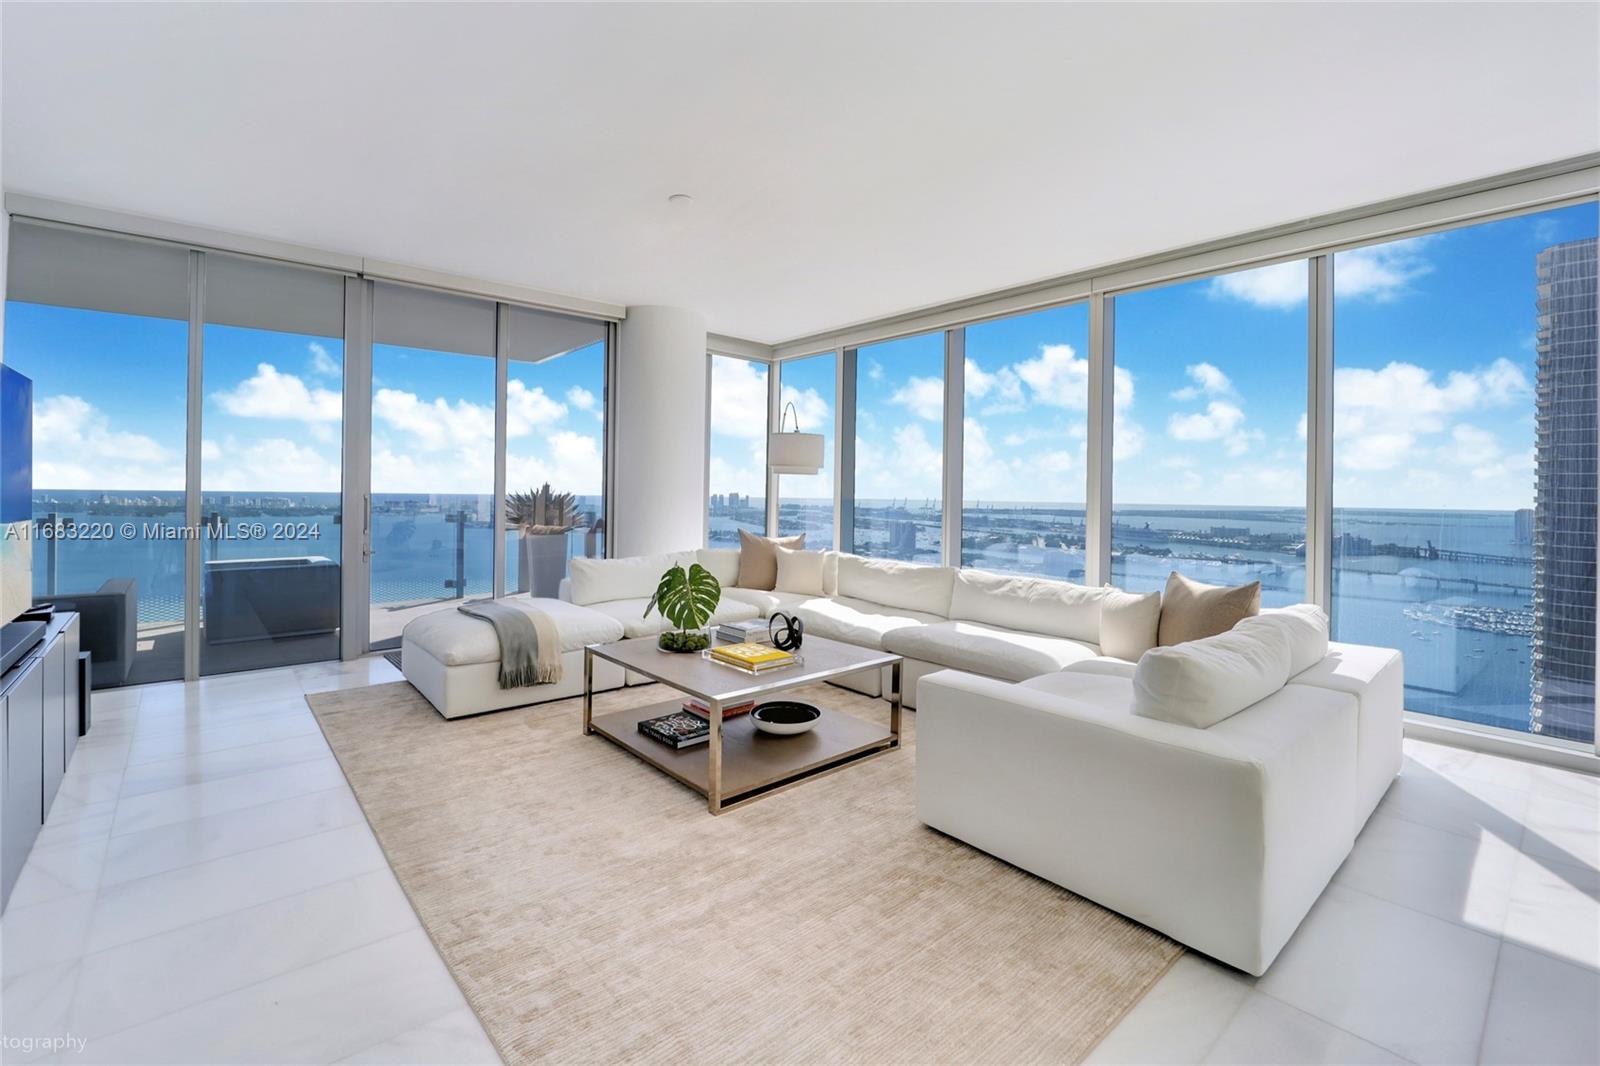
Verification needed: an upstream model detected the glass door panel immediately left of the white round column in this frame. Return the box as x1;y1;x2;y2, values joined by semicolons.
501;307;606;597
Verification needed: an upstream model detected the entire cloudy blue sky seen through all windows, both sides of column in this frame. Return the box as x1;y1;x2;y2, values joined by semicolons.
6;205;1597;509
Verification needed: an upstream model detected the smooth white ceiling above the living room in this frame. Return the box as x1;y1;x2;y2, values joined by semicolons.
3;3;1600;343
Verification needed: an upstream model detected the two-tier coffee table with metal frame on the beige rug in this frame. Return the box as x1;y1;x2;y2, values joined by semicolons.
584;637;901;815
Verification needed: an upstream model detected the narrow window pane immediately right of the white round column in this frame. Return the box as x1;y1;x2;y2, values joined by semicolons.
706;355;766;547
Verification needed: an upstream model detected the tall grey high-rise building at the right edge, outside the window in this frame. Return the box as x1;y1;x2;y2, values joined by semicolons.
1531;237;1600;743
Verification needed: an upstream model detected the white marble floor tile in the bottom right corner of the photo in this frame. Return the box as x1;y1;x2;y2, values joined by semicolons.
1482;943;1600;1066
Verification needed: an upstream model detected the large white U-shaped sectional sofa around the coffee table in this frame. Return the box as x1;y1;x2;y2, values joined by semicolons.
403;549;1403;975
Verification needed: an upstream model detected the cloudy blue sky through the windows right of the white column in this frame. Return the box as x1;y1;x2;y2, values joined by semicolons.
712;205;1597;509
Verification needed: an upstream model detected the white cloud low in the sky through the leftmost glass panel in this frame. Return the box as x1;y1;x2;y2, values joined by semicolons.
34;395;184;490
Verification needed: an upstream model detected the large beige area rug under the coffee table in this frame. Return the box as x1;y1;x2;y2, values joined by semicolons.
309;682;1182;1063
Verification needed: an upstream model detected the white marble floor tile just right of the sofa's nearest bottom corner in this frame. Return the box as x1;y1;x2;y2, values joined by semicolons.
1256;885;1499;1063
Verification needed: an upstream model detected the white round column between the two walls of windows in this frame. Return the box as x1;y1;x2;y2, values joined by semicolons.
611;306;709;555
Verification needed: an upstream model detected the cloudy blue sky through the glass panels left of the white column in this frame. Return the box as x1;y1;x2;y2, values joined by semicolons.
6;304;605;495
